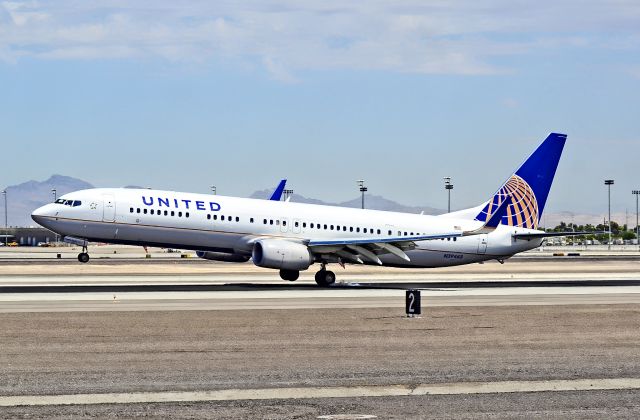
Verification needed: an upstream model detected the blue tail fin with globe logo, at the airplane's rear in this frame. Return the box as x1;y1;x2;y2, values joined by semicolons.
476;133;567;229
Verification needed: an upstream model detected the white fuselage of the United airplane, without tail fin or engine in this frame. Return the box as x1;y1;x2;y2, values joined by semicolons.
33;189;542;267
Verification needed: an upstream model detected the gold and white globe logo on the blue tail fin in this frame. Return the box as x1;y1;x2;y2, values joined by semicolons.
476;175;538;229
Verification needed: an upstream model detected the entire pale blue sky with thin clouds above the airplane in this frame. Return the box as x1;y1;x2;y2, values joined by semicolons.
0;0;640;213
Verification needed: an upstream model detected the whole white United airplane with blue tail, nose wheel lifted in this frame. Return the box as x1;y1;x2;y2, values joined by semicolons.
31;133;583;287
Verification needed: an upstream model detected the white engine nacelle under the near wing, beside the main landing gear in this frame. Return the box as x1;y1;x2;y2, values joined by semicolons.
252;239;313;271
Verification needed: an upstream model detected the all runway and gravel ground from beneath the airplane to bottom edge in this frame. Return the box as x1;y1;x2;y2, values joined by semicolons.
0;249;640;418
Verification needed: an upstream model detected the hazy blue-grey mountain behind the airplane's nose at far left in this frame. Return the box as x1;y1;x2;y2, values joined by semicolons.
0;175;93;226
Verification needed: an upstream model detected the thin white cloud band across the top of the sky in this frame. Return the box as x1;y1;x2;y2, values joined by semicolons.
0;0;640;75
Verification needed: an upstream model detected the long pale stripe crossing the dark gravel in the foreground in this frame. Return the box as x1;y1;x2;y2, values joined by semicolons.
0;378;640;407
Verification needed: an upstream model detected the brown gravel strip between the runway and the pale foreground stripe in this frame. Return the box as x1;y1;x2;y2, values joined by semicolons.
0;305;640;395
